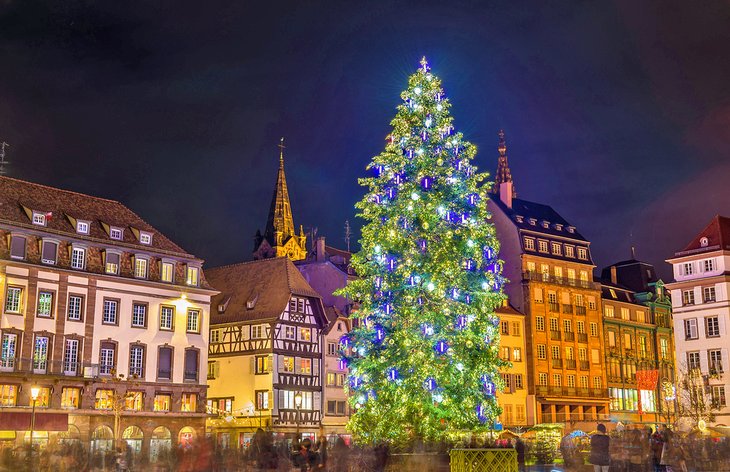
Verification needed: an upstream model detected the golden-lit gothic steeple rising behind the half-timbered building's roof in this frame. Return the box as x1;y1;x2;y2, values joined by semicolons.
254;138;307;261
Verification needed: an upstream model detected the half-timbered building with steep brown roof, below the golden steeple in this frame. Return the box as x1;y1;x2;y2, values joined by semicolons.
206;257;328;447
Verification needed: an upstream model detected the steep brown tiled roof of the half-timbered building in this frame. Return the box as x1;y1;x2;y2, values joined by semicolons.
205;257;321;325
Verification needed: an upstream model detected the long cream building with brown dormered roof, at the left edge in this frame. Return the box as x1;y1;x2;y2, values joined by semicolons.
0;177;215;460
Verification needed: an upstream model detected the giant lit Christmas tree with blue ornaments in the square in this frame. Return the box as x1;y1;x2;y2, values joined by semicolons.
340;58;504;444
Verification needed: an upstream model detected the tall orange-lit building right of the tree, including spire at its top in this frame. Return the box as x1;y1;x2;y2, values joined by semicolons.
488;134;609;429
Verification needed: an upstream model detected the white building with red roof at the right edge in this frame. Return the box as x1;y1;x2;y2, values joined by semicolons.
667;216;730;426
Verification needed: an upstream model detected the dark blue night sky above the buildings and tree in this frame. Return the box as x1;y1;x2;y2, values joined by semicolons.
0;0;730;277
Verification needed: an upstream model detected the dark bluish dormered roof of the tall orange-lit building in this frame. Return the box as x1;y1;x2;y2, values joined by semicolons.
492;198;588;243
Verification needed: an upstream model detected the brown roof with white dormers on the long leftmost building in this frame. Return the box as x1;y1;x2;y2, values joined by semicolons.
0;176;193;257
